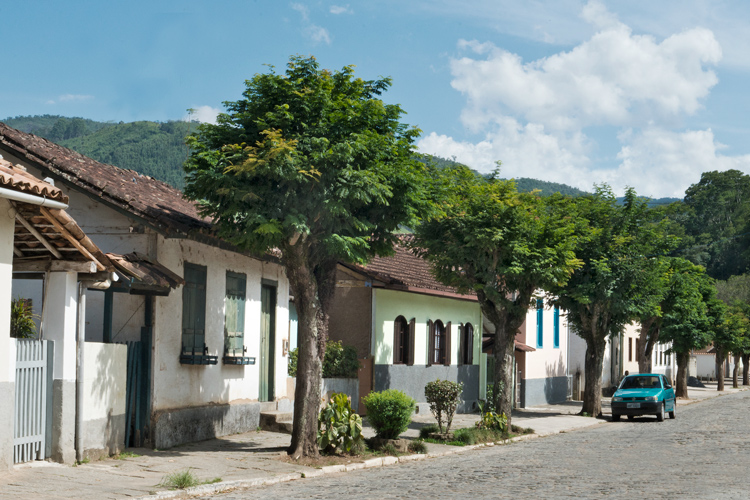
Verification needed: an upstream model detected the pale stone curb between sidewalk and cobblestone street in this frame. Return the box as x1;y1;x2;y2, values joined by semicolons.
134;420;604;500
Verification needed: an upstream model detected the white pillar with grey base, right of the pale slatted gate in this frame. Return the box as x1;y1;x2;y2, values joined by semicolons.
42;272;78;463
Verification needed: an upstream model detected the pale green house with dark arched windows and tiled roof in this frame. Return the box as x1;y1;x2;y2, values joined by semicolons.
329;241;484;412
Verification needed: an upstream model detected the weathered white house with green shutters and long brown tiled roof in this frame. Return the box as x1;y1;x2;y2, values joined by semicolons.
0;123;292;448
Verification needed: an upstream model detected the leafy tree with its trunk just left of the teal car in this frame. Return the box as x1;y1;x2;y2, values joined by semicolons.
555;186;670;417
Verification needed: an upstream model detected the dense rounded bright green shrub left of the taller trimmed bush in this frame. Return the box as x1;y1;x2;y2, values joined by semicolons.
362;389;417;439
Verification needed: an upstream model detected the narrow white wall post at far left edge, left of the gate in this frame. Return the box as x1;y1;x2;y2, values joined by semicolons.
0;198;16;471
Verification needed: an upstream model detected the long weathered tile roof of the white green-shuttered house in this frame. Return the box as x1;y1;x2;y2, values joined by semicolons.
0;122;211;235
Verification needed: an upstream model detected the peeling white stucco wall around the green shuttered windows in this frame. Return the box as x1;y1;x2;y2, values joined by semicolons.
152;236;291;411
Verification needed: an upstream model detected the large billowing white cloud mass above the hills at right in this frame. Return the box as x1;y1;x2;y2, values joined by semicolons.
418;0;750;197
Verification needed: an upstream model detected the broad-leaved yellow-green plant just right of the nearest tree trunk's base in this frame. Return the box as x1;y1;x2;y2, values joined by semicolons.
318;393;364;453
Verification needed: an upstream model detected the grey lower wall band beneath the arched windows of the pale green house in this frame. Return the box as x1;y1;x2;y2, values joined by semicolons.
373;365;479;413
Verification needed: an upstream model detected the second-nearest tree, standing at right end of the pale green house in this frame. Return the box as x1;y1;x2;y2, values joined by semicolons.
414;166;580;421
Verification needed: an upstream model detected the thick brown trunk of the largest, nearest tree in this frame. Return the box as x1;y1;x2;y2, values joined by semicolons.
282;241;336;460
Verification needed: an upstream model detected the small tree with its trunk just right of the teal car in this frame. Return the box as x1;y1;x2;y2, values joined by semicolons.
660;258;716;398
